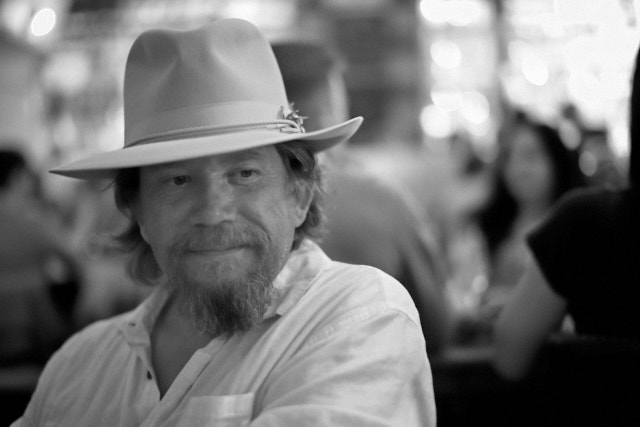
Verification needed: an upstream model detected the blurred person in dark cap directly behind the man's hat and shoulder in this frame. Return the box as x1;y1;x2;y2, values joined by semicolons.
272;40;451;354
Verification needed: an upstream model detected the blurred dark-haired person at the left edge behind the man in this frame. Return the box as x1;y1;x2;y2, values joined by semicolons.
0;148;83;366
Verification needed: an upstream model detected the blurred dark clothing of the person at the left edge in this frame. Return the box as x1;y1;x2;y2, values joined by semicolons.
0;207;78;365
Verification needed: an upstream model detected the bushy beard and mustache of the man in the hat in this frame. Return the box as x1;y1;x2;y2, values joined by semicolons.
166;226;288;339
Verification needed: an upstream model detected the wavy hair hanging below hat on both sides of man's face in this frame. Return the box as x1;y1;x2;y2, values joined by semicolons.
113;141;325;284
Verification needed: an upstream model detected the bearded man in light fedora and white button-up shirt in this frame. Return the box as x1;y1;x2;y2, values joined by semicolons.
16;19;435;426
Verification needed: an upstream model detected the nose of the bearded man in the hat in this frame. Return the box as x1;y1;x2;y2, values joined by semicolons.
191;180;236;226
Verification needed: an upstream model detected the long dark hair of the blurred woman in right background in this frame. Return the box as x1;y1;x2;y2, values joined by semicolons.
477;113;584;257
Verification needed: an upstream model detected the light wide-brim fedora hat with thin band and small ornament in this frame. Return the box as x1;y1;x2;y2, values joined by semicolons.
51;19;362;179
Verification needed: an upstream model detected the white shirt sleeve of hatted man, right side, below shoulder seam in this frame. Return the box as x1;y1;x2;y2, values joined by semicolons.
251;308;436;427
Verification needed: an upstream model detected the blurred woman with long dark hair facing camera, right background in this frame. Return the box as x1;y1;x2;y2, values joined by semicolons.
476;112;584;322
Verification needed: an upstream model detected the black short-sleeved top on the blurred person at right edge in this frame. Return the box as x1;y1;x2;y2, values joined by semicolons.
528;189;640;339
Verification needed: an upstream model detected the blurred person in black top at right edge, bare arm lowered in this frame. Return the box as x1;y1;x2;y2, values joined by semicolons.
495;45;640;382
